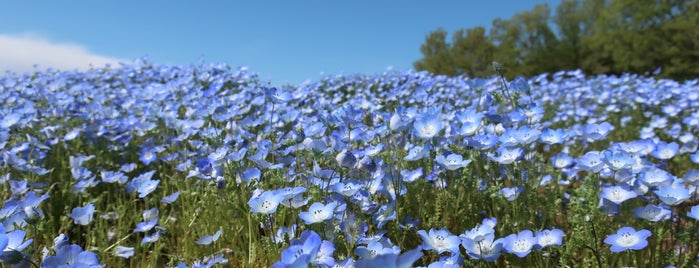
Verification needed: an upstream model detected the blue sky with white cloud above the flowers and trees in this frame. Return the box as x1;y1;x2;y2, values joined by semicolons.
0;0;560;85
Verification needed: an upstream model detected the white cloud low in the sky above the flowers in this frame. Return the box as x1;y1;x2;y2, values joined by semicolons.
0;33;130;74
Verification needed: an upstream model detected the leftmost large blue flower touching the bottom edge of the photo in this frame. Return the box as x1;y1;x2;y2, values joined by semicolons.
41;244;102;268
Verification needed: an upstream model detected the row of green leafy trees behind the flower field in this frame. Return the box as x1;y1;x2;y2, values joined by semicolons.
414;0;699;80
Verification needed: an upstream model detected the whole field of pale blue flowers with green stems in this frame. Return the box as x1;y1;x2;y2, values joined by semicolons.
0;60;699;267
